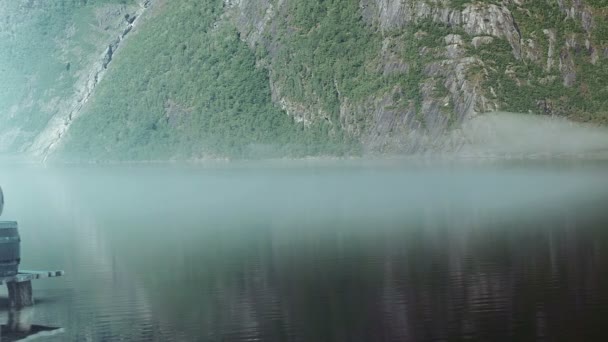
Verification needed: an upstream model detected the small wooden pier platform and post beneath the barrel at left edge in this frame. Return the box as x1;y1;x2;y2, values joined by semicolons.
0;270;65;308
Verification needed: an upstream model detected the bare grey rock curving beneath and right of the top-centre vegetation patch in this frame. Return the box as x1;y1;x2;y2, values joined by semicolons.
224;0;521;152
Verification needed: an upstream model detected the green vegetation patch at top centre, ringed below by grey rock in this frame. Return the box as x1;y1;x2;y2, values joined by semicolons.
273;1;382;121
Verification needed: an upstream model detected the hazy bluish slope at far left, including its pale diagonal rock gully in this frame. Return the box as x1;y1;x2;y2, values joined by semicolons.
0;0;145;155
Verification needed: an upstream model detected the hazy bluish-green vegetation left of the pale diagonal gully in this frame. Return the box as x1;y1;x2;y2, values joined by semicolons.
0;0;136;148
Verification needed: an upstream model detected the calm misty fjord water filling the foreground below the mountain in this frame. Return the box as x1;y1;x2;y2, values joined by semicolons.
0;160;608;341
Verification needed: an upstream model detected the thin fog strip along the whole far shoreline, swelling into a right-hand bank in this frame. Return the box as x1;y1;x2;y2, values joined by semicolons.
0;112;608;162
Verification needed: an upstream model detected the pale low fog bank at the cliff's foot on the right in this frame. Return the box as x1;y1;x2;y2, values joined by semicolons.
451;112;608;157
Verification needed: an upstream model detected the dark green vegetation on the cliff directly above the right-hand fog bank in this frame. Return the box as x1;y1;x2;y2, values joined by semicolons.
480;0;608;124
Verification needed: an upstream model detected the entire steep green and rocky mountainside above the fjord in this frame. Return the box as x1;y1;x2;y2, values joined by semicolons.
0;0;608;160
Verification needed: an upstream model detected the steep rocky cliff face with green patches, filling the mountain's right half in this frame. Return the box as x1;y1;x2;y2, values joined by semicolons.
225;0;608;152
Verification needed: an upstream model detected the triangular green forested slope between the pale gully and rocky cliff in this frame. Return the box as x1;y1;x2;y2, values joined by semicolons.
64;0;357;159
